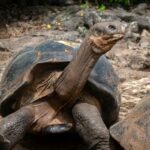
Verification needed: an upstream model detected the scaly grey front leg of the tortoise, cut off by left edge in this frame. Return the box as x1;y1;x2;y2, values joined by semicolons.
0;106;34;150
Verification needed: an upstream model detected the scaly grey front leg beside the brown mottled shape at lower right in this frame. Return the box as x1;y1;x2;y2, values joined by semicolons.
72;99;122;150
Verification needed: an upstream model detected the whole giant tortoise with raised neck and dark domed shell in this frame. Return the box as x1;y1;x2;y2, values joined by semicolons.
0;21;125;150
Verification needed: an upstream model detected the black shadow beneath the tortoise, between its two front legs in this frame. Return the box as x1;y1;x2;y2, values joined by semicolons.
13;134;86;150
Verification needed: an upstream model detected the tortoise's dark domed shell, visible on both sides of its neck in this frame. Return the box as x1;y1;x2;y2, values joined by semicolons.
0;41;120;126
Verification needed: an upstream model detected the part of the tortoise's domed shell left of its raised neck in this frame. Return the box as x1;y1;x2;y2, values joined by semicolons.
0;41;73;116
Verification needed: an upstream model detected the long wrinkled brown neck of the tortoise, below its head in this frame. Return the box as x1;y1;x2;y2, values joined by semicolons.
54;37;110;103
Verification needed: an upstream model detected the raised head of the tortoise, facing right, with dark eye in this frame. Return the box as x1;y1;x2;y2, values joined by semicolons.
88;21;126;54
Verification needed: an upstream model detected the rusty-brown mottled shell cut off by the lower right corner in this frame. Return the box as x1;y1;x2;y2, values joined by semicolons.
110;96;150;150
